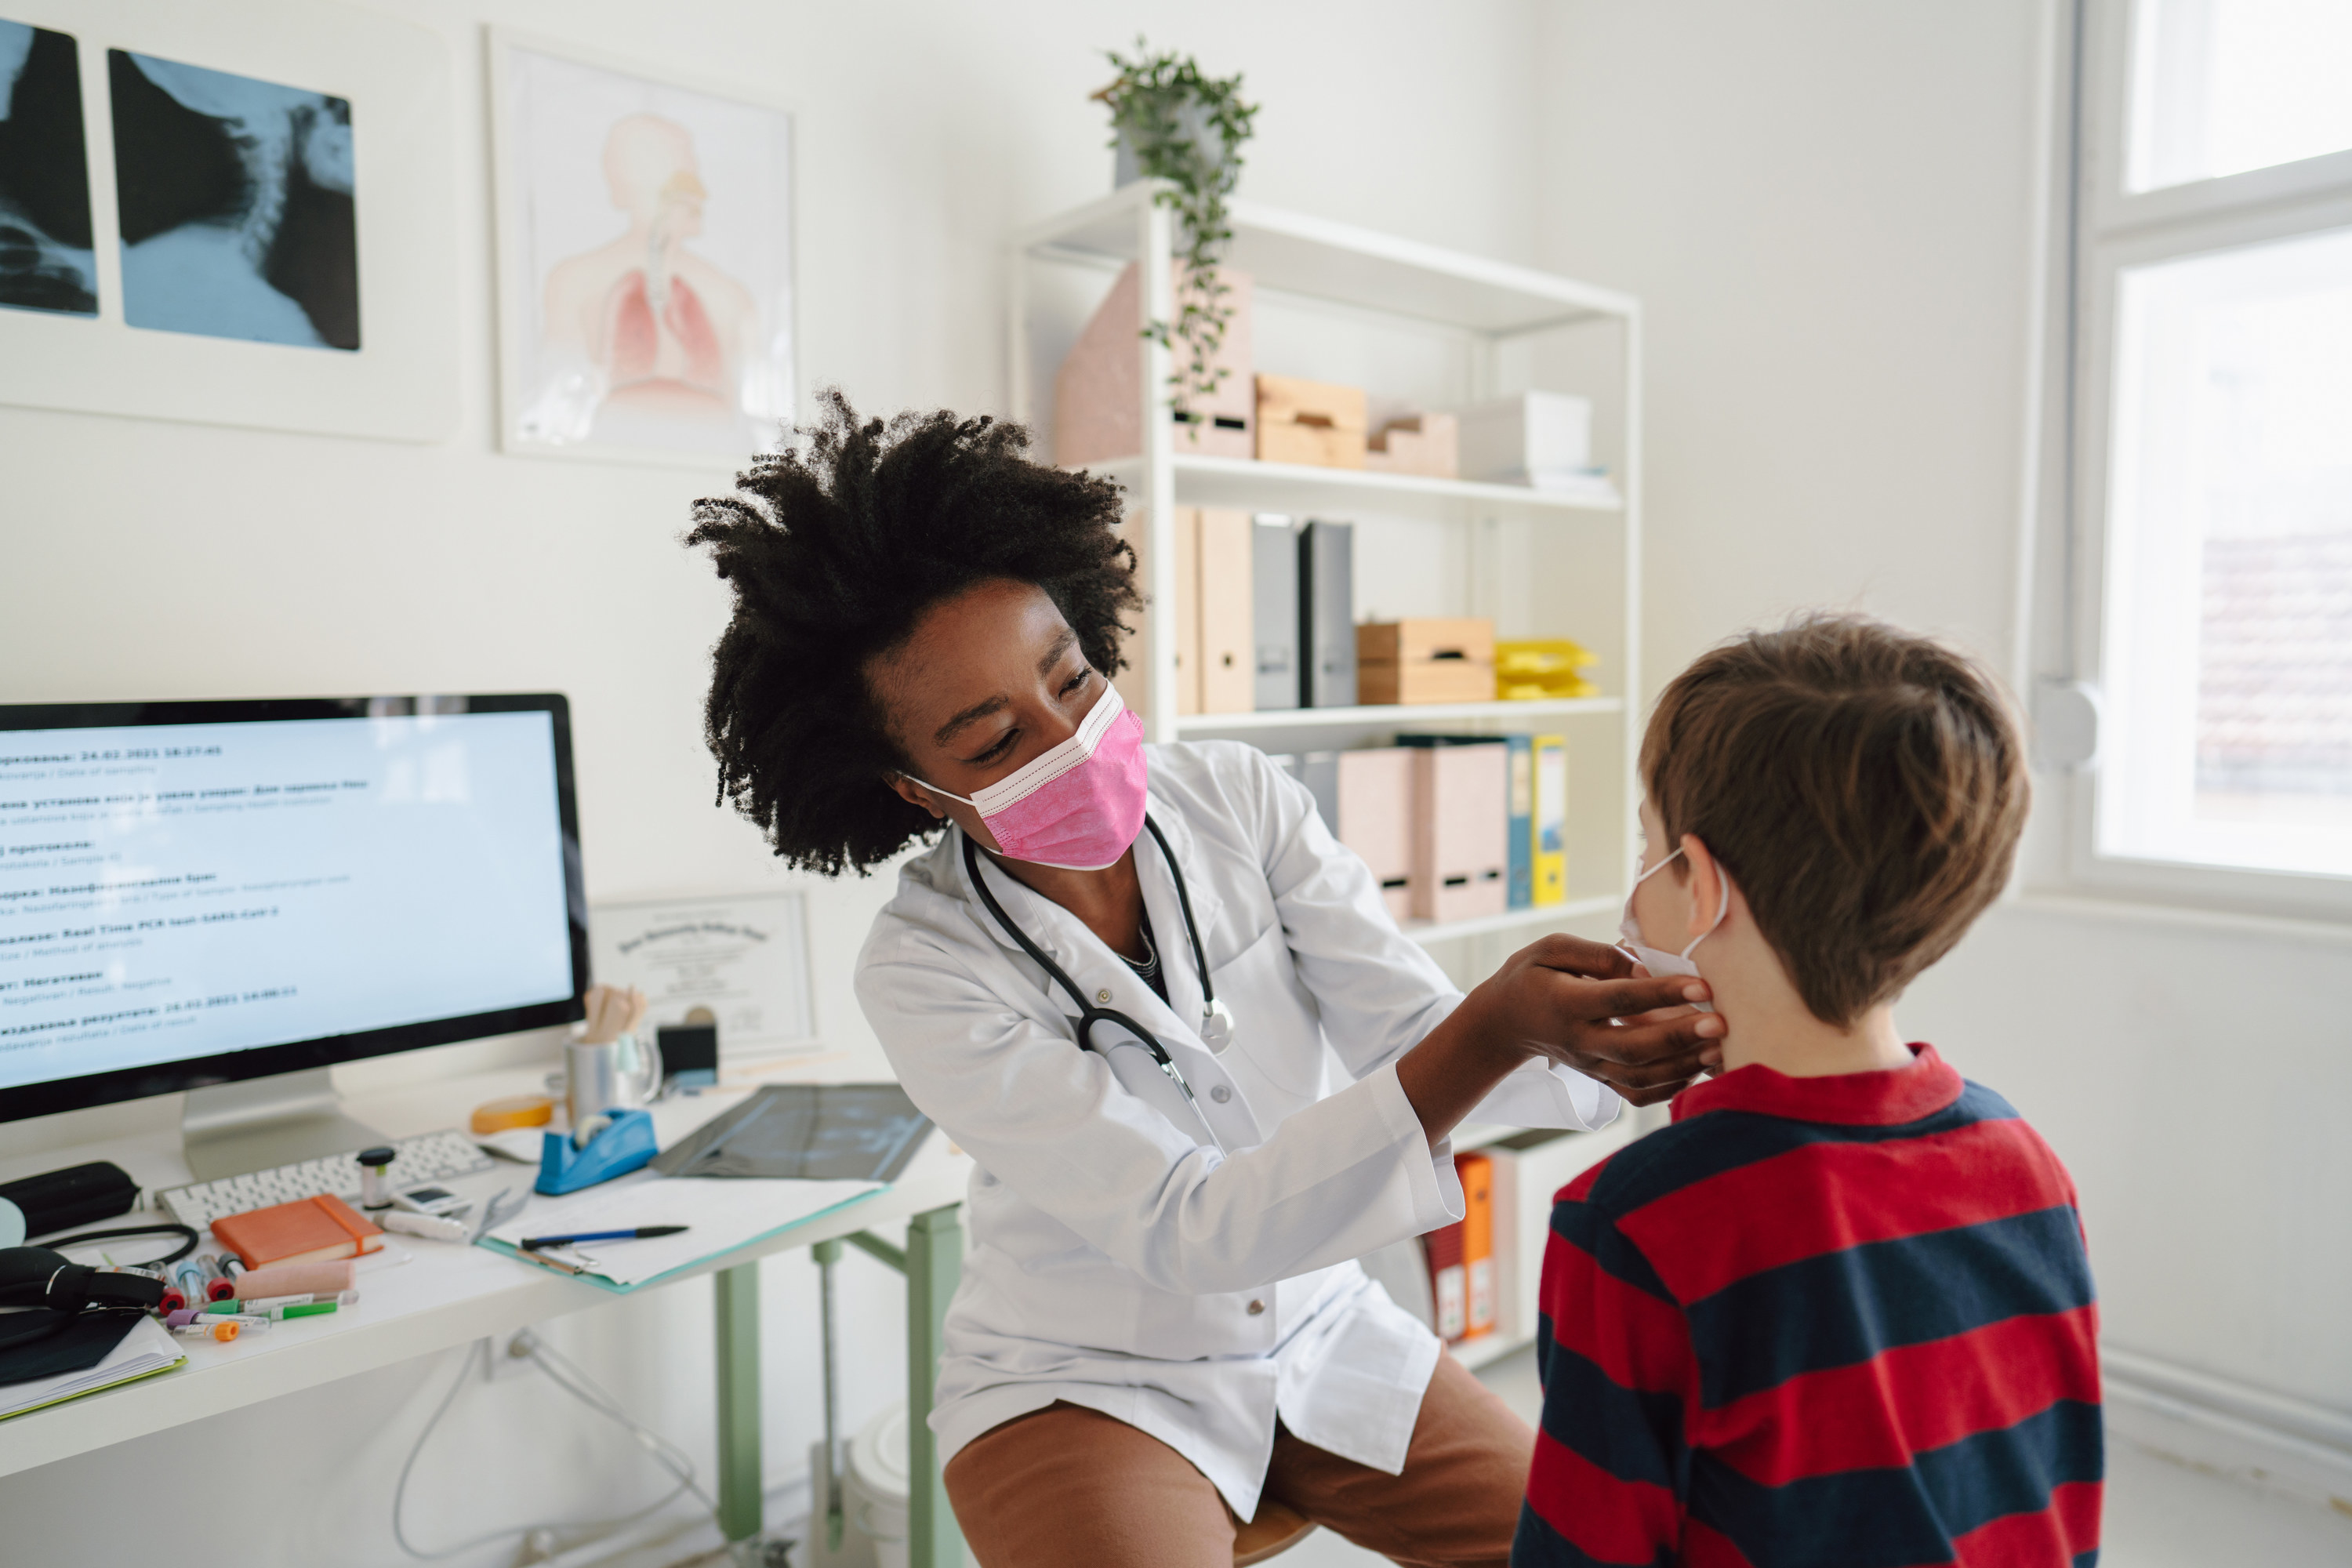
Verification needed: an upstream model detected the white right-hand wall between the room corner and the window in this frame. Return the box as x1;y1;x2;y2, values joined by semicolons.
1541;0;2352;1410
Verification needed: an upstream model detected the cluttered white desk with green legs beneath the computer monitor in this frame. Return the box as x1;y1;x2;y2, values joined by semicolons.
0;1067;971;1568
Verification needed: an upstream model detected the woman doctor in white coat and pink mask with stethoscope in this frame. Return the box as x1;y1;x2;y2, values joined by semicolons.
689;395;1722;1568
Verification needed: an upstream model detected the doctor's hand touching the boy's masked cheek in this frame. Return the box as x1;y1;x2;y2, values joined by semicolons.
1479;935;1724;1105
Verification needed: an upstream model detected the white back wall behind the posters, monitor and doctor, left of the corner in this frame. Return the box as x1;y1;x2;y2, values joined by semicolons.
0;0;1536;1568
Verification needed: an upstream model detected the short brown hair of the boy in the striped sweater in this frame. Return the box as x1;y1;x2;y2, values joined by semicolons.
1642;616;2030;1027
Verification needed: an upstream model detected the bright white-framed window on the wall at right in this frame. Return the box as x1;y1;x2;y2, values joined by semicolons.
2070;0;2352;914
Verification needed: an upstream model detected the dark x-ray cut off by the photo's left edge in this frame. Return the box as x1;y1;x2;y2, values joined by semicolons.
0;19;99;315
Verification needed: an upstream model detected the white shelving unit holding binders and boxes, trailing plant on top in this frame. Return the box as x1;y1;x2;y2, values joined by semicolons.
1007;181;1642;942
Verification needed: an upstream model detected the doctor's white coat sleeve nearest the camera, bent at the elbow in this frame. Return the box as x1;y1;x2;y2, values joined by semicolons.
856;933;1461;1295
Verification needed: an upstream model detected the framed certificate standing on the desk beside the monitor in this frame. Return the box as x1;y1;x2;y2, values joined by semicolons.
588;893;818;1062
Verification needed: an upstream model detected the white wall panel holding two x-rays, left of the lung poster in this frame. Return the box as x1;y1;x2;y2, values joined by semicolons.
0;0;456;440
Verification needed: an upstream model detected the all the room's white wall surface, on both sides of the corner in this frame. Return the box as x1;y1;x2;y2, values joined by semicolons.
0;0;2352;1563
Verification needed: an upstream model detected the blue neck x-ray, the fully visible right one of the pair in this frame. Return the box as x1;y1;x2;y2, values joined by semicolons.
106;49;360;348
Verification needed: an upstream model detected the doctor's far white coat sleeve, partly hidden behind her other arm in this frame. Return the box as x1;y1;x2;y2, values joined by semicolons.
1254;762;1623;1131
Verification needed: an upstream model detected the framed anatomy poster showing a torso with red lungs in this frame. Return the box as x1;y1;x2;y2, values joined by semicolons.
489;31;795;468
